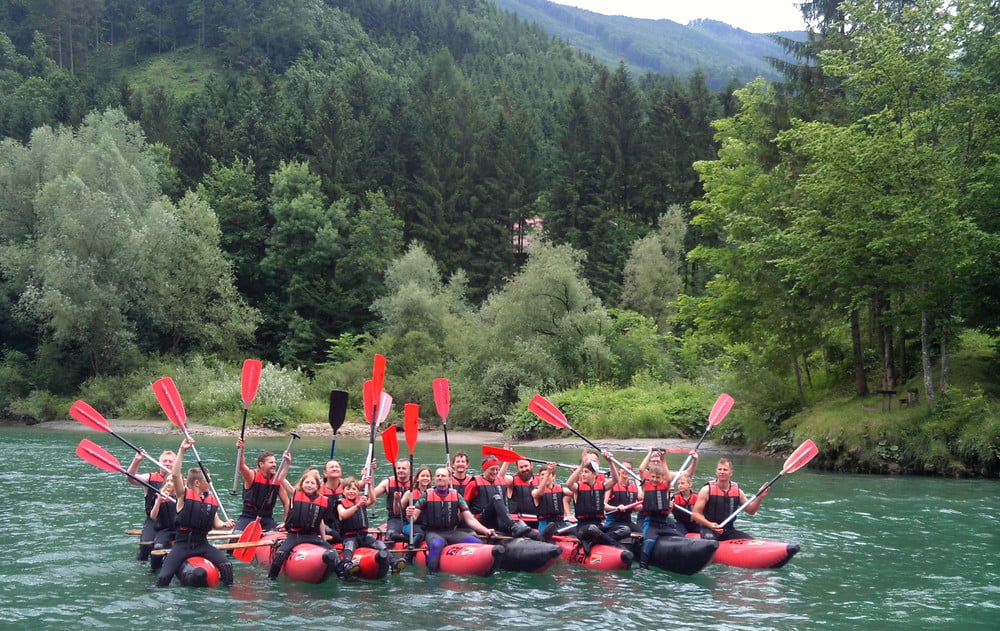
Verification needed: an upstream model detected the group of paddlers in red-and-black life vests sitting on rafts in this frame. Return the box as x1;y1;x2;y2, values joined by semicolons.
123;439;766;586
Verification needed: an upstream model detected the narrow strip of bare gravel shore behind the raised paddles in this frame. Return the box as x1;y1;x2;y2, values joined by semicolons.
25;420;736;454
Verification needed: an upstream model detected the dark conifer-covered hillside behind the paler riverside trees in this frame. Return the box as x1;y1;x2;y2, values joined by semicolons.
0;0;726;376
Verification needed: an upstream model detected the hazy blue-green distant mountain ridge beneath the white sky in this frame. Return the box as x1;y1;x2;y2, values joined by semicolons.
493;0;804;89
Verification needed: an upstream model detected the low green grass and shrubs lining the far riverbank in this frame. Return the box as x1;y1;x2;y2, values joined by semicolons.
7;334;1000;477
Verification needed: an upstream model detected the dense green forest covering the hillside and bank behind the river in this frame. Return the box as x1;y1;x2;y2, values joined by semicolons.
0;0;1000;475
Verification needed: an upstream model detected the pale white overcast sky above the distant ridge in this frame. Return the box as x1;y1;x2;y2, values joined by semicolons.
552;0;805;33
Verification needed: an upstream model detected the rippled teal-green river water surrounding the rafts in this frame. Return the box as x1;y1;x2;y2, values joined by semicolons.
0;424;1000;631
